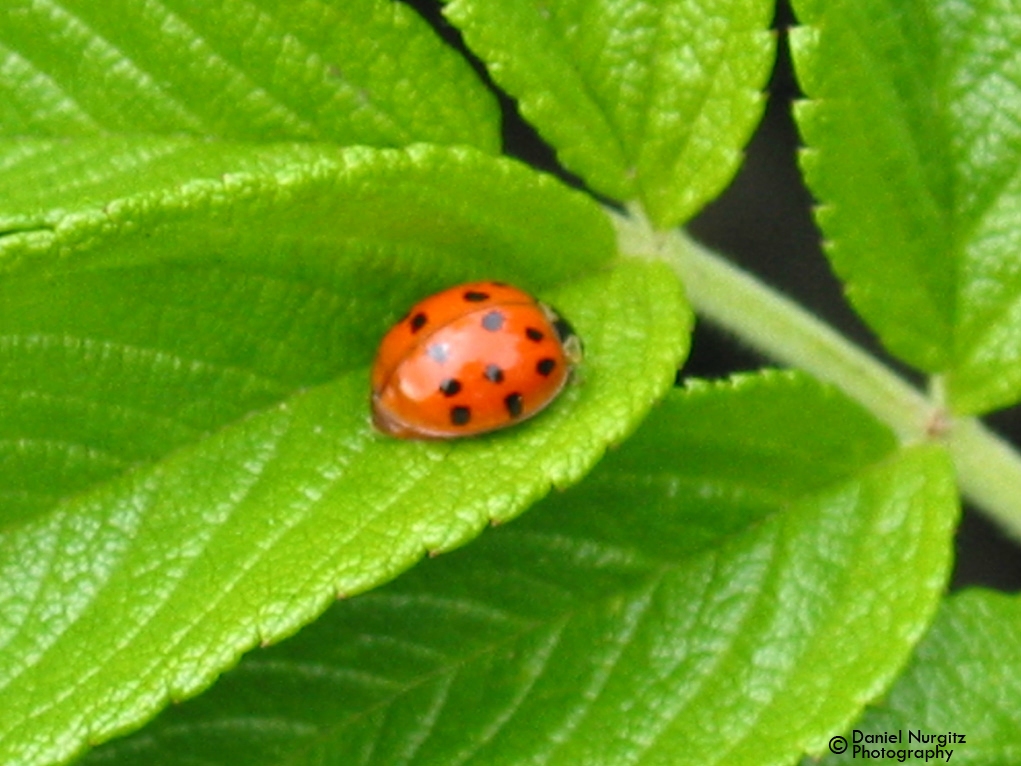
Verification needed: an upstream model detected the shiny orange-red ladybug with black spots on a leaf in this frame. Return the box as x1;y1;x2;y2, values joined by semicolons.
372;282;581;439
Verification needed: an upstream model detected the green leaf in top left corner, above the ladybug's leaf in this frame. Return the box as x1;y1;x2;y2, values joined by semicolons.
0;0;500;153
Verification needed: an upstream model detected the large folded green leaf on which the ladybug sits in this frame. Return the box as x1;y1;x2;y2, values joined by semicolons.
0;138;690;764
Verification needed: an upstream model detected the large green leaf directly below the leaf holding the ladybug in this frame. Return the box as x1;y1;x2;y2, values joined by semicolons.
77;373;957;766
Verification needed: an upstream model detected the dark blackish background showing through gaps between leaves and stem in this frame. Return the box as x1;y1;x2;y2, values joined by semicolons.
407;0;1021;590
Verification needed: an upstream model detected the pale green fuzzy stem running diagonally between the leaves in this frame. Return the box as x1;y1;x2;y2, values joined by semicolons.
611;210;1021;539
